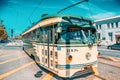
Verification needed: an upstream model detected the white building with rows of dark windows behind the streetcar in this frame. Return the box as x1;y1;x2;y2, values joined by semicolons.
95;16;120;45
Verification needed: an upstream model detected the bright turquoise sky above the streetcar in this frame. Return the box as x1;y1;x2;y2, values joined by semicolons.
0;0;120;36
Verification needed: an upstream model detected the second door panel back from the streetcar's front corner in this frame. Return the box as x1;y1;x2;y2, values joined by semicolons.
42;26;51;68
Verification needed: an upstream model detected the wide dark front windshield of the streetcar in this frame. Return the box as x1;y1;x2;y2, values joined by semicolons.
57;27;96;44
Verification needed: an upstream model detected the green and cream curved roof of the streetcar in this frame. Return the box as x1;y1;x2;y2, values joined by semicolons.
22;14;93;35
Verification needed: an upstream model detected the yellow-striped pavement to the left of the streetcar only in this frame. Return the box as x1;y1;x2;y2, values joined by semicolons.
0;47;46;80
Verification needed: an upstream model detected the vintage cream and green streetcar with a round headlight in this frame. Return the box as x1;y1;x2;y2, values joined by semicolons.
22;14;98;78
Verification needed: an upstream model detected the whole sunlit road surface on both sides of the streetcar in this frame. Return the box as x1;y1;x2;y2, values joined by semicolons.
0;44;120;80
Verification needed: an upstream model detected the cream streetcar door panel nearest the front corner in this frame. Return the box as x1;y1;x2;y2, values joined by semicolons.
49;25;58;71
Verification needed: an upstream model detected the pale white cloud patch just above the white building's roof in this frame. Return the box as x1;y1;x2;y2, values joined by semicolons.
92;12;115;20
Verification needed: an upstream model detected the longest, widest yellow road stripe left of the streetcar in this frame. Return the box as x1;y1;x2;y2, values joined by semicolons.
0;61;35;79
